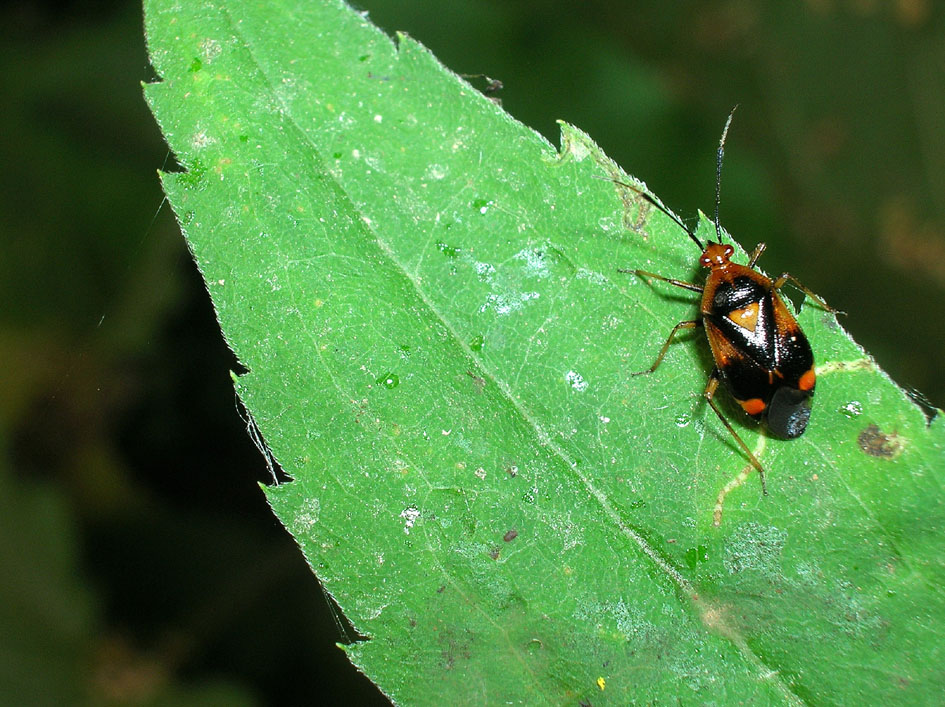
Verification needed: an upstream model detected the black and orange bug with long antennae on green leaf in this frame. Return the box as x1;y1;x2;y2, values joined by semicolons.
620;109;838;495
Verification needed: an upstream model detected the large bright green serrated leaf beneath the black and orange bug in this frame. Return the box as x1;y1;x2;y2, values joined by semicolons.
146;0;945;704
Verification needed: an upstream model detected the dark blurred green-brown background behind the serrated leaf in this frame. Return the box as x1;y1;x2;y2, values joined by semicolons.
0;0;945;705
